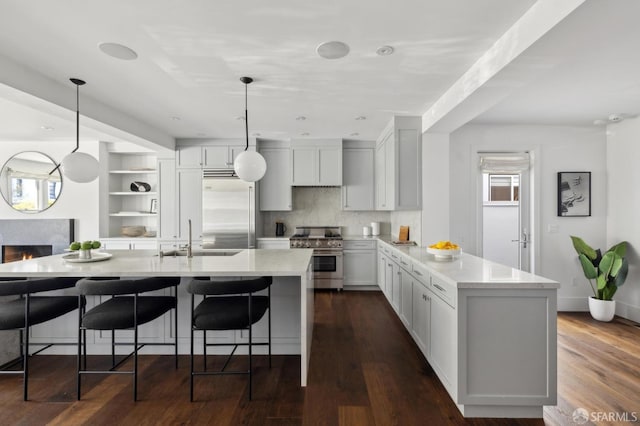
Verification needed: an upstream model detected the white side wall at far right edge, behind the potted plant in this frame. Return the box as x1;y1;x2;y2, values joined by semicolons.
606;118;640;322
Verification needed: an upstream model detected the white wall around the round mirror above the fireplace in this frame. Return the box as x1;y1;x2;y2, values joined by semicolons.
0;139;99;240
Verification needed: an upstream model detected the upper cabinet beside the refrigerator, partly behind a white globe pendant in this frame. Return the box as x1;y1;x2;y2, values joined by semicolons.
258;141;293;211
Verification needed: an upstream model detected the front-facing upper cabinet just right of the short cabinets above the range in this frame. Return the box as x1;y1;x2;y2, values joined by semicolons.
342;141;375;210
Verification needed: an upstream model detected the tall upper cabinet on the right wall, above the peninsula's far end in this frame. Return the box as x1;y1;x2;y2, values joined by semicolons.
375;117;422;210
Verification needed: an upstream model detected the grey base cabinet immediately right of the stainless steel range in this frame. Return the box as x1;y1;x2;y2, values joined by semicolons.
343;240;377;289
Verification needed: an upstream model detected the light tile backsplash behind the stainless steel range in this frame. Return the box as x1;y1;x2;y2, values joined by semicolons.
262;187;390;237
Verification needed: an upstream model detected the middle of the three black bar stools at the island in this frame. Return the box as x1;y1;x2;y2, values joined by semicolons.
77;277;180;401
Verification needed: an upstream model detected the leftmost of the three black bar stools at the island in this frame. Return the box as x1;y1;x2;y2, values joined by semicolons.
0;277;85;401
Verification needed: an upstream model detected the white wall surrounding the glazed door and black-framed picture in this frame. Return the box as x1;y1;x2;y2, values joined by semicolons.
448;125;607;310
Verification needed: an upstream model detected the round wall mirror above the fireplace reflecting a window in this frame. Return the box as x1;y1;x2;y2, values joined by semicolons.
0;151;62;213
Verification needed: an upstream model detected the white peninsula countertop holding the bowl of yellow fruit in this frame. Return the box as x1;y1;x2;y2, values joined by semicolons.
377;235;560;289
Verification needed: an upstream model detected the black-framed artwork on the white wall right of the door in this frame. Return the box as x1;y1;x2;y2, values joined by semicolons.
558;172;591;217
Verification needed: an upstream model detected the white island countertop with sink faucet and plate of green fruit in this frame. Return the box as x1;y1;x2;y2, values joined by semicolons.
0;249;313;278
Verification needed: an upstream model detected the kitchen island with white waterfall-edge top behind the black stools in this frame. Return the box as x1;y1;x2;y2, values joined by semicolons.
0;249;314;386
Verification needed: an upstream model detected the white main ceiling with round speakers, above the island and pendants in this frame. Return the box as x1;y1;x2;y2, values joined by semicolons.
0;0;534;145
